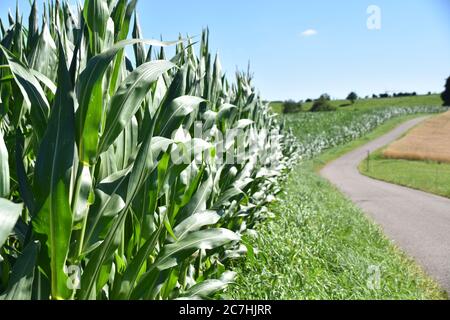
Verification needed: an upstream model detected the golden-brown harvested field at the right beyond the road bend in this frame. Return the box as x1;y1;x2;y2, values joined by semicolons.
384;111;450;162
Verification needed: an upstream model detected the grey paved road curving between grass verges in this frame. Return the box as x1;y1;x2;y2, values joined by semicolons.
321;117;450;293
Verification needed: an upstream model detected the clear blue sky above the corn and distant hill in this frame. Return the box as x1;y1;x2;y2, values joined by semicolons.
0;0;450;100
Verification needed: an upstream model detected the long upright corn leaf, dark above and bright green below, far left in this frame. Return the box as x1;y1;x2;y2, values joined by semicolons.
34;44;75;299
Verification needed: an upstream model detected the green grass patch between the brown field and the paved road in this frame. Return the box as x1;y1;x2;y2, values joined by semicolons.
359;150;450;198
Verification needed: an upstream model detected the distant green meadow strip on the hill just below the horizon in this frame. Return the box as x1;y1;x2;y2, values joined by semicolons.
271;94;442;113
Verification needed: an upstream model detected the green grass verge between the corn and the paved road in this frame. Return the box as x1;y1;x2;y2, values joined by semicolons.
228;114;447;300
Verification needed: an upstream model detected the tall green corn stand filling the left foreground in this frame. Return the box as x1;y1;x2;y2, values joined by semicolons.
0;0;294;300
